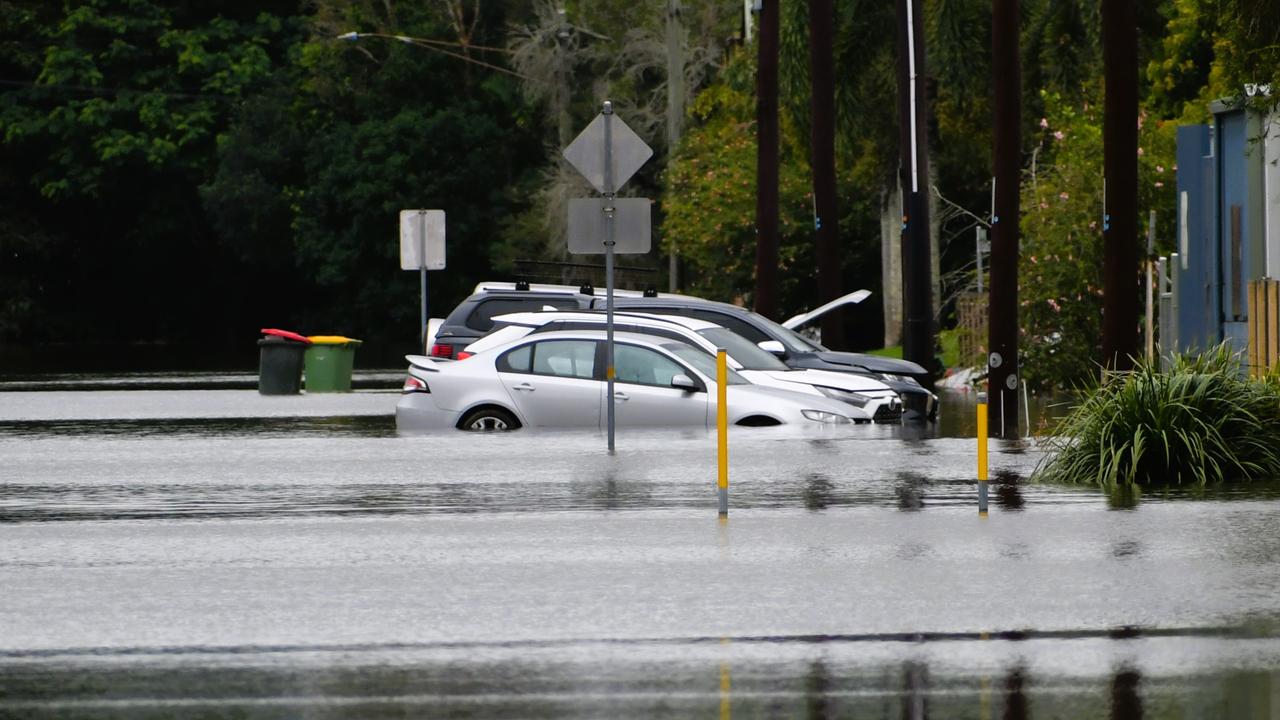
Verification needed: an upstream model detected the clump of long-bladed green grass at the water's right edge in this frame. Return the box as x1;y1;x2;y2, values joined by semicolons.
1036;345;1280;487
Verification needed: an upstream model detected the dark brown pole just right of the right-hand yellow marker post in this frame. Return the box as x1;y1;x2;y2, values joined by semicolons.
987;0;1023;438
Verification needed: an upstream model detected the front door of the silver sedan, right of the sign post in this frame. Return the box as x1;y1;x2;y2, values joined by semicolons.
600;343;709;427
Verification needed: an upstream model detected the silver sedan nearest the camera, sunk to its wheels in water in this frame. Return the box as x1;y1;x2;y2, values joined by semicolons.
396;331;852;433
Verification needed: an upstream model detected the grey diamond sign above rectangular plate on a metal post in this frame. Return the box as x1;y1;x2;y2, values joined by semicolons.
563;100;653;452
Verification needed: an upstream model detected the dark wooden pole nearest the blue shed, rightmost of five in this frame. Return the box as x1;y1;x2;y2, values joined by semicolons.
1102;0;1138;370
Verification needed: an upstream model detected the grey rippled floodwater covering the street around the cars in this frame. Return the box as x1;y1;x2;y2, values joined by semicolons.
0;371;1280;719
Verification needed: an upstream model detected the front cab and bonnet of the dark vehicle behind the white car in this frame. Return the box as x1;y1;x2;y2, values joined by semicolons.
593;293;938;420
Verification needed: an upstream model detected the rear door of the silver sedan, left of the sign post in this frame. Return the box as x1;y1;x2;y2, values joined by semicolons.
497;340;604;428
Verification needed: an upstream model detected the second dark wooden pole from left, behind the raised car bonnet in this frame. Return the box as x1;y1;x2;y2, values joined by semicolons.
809;0;845;350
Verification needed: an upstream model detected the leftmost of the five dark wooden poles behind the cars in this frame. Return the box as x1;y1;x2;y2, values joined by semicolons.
755;0;782;318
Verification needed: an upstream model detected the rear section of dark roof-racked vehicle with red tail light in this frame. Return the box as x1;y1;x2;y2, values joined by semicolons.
430;282;640;359
